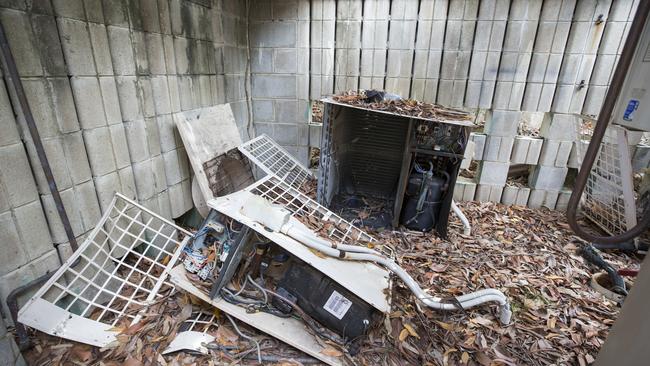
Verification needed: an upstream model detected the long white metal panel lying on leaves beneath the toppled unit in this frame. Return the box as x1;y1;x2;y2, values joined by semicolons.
170;265;347;365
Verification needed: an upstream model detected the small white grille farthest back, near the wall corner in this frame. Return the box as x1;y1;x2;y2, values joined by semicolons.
239;134;314;188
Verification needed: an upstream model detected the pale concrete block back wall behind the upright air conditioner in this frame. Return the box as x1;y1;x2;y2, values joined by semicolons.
250;0;638;209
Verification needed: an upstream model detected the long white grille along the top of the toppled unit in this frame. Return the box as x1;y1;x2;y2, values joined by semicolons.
246;176;394;257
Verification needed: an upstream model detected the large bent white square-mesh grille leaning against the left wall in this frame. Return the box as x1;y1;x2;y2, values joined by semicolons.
20;193;191;346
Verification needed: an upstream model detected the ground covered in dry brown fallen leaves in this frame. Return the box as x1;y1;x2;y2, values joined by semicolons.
21;202;639;366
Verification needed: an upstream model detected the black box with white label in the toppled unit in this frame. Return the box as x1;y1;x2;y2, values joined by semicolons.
278;258;381;341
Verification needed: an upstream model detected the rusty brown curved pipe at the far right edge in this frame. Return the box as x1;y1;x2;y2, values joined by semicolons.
566;1;650;244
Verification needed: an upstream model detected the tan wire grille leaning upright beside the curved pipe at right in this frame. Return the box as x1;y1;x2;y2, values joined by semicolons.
577;126;636;235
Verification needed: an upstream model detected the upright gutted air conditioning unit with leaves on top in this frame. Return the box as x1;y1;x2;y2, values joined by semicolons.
317;97;473;237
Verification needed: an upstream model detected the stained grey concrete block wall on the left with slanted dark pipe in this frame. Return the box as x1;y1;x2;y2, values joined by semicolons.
0;0;249;326
